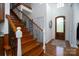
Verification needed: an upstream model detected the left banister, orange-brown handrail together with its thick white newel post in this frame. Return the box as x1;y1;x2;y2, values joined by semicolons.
6;15;22;56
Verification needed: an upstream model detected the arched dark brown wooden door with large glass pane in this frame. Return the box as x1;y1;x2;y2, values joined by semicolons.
55;16;65;40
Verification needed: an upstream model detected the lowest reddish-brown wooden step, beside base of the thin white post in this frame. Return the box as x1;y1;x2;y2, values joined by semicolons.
24;47;43;56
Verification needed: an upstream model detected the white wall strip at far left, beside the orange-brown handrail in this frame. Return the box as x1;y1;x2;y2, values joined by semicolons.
1;3;10;34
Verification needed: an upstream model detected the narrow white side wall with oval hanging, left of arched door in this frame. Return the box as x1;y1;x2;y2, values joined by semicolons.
45;4;54;43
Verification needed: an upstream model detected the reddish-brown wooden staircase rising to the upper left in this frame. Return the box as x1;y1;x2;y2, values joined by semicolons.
6;12;44;56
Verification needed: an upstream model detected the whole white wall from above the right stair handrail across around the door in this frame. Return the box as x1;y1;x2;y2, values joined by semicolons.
32;3;77;47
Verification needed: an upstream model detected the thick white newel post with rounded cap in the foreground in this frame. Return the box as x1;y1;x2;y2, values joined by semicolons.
16;27;22;56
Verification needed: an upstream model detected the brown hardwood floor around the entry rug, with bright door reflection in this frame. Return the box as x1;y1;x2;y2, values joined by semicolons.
45;40;79;56
